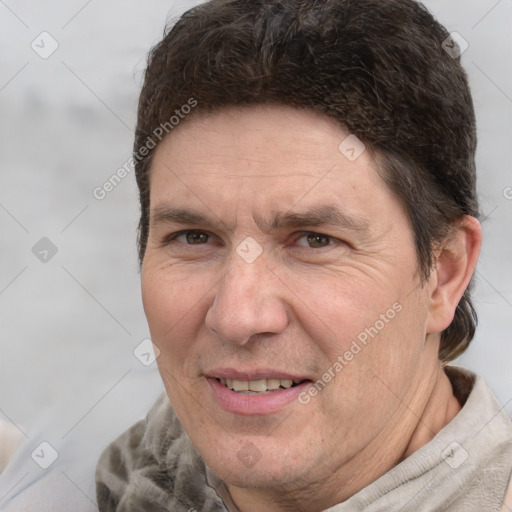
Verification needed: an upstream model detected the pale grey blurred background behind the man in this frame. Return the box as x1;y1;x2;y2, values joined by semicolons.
0;0;512;512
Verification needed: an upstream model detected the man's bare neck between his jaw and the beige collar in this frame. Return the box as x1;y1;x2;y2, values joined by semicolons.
228;356;461;512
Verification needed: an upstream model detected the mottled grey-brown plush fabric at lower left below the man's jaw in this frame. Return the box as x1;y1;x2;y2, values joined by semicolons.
96;392;222;512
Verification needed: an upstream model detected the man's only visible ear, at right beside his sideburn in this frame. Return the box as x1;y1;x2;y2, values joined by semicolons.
427;215;482;333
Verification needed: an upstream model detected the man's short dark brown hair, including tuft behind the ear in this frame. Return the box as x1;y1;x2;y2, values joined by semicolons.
134;0;479;361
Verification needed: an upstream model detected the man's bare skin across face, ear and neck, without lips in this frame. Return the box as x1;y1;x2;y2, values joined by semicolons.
142;106;481;512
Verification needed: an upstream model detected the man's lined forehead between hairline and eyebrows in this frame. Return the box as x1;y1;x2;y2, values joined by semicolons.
146;105;395;222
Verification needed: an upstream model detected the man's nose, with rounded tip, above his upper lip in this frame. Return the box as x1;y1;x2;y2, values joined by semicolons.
205;247;289;345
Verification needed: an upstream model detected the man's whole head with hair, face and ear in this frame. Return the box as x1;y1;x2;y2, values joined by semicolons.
135;0;480;505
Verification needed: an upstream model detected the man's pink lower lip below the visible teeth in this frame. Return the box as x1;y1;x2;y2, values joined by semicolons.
207;377;311;416
